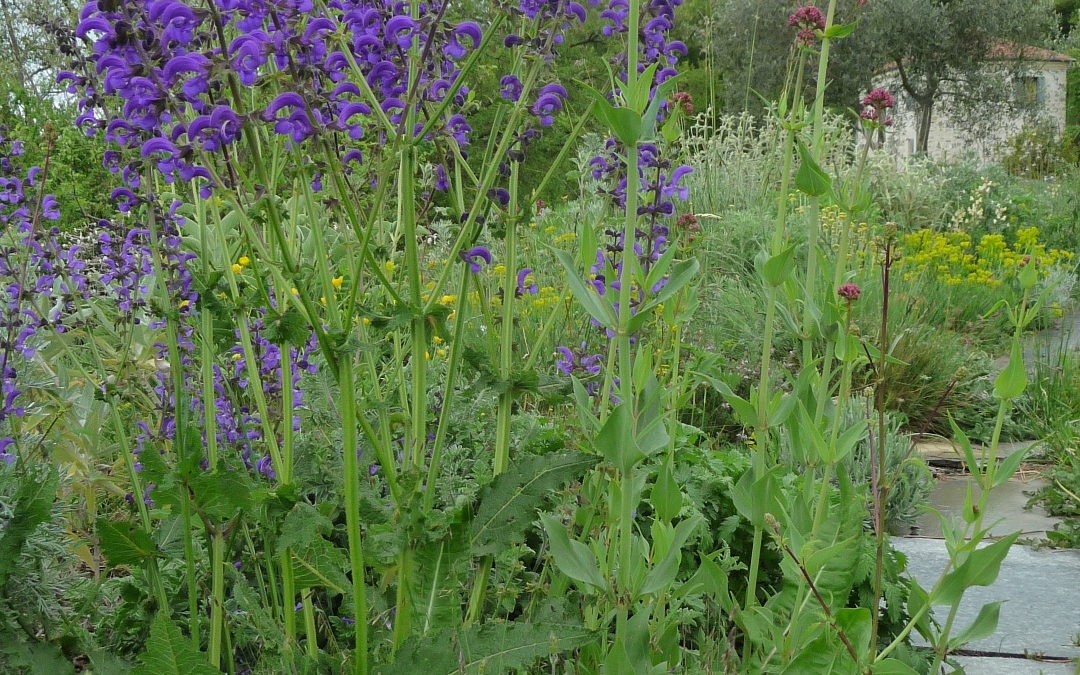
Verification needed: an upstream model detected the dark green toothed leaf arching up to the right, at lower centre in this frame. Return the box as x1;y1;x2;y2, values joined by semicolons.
469;453;599;556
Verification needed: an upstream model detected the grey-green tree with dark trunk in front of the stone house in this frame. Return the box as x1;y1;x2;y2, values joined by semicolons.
854;0;1054;152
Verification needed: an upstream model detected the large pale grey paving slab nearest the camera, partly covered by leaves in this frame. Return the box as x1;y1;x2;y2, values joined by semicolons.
892;537;1080;660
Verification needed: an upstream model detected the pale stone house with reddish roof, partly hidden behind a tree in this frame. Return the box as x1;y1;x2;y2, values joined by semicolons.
875;42;1074;164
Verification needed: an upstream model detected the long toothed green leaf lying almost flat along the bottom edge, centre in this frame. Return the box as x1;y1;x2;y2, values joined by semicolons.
374;622;598;675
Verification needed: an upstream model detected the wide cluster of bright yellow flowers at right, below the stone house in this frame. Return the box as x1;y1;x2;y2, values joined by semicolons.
897;227;1072;286
